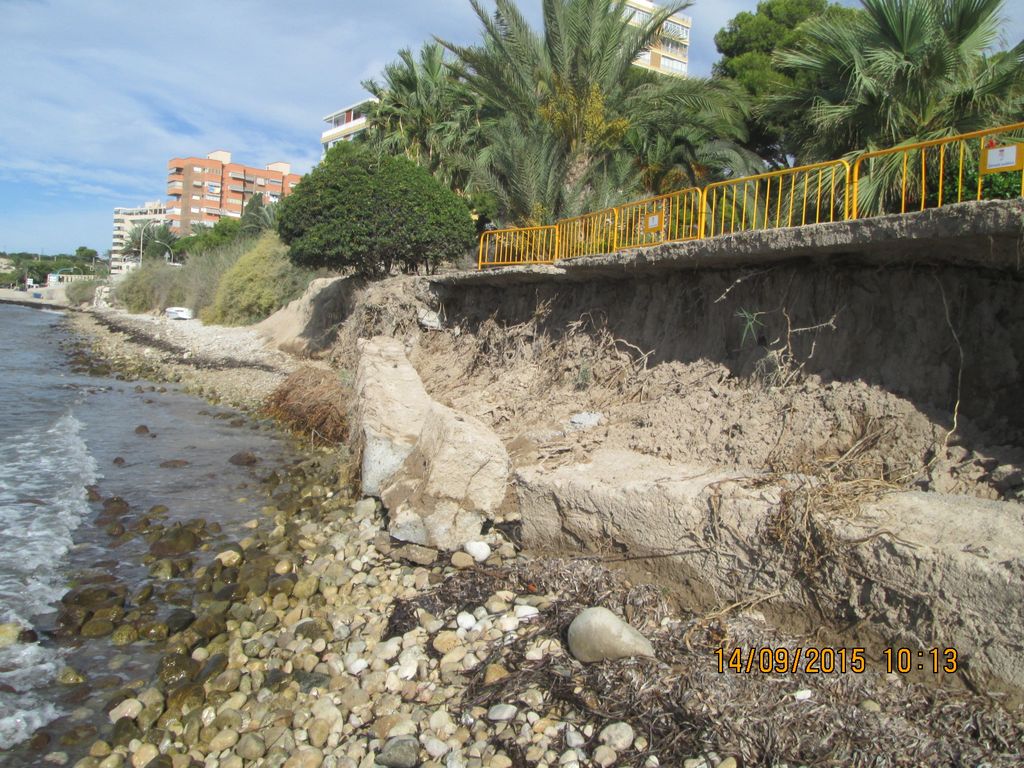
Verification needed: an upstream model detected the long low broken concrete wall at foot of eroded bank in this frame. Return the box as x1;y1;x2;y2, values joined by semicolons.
514;450;1024;697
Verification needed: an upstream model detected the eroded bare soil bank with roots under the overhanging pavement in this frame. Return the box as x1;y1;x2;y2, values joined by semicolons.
334;269;1024;507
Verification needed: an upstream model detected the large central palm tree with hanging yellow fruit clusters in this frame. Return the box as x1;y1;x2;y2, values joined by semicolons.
441;0;743;223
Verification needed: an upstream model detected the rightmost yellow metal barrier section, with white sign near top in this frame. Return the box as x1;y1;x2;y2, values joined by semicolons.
850;123;1024;218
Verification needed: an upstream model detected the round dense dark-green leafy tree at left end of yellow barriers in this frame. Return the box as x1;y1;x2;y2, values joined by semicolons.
278;142;475;278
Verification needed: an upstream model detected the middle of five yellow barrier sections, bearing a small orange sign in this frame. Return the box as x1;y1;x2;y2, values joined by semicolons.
615;187;700;250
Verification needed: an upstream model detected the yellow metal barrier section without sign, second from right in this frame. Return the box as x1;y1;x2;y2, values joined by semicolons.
700;160;850;238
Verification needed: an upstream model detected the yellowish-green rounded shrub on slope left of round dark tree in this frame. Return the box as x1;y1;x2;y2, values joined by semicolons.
203;232;312;326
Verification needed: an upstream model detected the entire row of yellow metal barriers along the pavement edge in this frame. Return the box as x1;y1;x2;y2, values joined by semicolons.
477;123;1024;269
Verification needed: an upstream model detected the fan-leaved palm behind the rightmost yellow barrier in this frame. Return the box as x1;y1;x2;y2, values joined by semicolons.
768;0;1024;162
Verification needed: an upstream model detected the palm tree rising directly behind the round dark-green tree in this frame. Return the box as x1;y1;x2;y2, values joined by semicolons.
362;43;481;190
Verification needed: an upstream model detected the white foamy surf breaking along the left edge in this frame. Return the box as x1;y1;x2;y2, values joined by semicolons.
0;412;97;749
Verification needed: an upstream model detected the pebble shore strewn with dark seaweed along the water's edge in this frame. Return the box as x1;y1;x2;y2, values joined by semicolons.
42;309;1024;768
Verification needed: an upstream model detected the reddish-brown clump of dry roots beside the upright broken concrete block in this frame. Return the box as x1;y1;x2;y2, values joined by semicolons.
266;367;348;445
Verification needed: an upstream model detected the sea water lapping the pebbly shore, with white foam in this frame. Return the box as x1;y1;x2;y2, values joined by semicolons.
0;304;295;766
